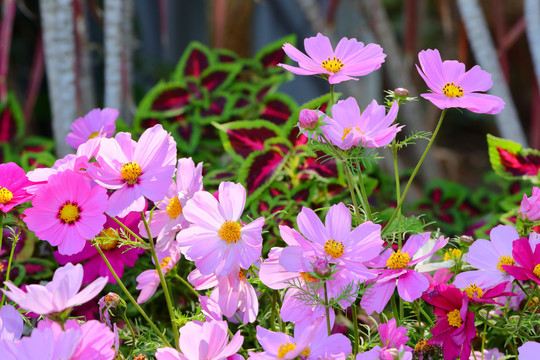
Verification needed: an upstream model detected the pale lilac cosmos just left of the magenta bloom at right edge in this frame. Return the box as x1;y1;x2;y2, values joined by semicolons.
454;225;519;289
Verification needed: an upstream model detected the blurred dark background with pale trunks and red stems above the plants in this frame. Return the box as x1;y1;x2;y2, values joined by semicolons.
0;0;540;187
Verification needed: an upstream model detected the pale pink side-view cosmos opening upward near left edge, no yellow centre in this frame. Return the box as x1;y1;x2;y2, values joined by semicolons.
2;263;107;315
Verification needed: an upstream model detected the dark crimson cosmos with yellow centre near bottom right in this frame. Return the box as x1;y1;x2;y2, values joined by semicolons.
423;285;476;360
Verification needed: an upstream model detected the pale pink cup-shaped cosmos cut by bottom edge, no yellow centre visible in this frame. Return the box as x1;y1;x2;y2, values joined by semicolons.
156;321;244;360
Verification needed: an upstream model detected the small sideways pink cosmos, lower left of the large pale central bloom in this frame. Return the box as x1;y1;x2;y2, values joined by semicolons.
136;245;180;304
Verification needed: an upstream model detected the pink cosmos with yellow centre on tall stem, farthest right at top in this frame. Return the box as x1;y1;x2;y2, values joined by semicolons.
416;49;504;114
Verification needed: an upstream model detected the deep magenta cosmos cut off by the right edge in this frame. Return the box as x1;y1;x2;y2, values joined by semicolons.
502;238;540;285
